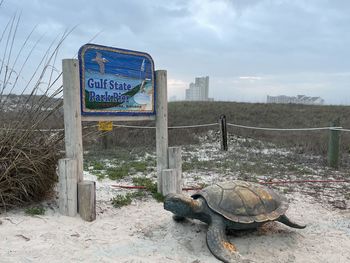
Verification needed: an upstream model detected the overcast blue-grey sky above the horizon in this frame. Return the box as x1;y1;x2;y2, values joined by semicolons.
0;0;350;104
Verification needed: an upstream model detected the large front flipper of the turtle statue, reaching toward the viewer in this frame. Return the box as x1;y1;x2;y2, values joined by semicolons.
207;218;252;263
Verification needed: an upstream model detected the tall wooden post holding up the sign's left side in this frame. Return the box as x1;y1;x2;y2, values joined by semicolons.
62;59;83;182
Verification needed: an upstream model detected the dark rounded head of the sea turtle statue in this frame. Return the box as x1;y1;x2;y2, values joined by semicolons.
164;194;201;218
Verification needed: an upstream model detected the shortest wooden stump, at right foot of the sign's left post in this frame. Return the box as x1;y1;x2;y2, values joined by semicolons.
78;181;96;222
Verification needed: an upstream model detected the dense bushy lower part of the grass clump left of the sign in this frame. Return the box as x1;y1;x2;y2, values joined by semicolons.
0;129;61;209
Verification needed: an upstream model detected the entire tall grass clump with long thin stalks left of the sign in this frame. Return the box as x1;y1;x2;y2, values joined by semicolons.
0;10;70;212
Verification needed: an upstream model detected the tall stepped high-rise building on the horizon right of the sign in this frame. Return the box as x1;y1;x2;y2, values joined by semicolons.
186;76;209;101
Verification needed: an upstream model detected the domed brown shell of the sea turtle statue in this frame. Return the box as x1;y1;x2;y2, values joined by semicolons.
192;180;288;224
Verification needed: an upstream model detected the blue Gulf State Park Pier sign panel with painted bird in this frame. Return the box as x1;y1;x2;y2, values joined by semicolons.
79;44;155;116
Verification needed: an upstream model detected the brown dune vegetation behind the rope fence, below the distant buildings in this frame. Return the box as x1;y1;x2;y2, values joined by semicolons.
93;102;350;159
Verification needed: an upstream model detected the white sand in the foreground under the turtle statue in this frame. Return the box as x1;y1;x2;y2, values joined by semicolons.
0;193;350;263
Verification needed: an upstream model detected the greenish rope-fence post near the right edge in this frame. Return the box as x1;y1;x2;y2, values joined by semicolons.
328;118;340;168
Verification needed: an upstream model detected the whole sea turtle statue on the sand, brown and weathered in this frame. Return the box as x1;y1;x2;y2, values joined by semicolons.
164;180;305;263
